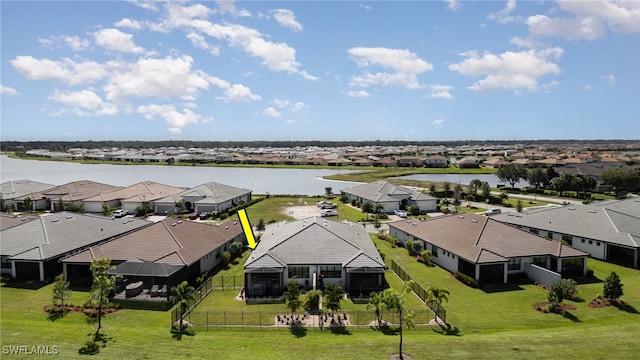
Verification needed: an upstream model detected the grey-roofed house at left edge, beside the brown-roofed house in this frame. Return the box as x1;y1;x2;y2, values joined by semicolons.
0;211;152;281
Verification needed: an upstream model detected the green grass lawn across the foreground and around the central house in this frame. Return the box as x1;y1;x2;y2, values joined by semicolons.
0;198;640;360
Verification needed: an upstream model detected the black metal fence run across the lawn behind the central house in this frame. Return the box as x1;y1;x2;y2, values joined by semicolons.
178;310;435;331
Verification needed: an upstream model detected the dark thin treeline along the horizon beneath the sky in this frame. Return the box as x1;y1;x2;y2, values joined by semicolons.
0;140;640;152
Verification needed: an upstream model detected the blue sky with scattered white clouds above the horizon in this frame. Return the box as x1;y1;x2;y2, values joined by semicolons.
0;1;640;141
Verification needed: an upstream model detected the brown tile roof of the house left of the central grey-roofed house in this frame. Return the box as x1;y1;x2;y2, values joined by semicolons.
62;218;243;265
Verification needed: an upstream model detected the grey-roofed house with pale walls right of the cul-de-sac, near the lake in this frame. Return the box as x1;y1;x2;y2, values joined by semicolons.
341;180;438;214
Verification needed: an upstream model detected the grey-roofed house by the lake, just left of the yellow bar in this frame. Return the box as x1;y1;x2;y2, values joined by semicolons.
153;182;251;214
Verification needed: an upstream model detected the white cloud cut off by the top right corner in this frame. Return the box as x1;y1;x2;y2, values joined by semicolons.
527;0;640;40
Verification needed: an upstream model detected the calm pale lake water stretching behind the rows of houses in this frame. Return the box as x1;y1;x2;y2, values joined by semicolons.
0;155;522;196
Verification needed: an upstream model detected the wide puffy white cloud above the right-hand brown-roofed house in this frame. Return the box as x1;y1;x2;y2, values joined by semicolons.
449;47;563;93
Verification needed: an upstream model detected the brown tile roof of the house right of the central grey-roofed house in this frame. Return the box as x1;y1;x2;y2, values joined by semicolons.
389;213;588;263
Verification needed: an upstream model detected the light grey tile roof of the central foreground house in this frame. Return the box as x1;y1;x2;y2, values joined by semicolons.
245;217;384;269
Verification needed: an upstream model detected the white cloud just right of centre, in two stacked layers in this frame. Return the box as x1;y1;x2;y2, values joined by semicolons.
347;47;433;89
